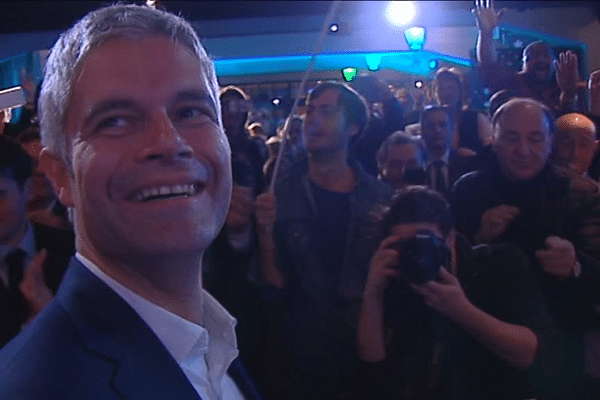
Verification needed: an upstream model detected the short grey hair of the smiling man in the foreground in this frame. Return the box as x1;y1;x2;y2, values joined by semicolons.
39;4;221;169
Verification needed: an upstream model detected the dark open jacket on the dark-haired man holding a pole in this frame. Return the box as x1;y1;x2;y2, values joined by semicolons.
273;159;393;378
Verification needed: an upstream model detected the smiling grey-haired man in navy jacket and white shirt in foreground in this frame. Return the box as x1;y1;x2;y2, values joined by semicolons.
0;5;262;400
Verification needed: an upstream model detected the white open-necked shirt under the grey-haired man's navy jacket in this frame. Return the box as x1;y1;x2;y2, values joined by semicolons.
75;253;244;400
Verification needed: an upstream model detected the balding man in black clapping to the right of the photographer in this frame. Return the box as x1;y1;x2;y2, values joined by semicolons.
452;98;600;399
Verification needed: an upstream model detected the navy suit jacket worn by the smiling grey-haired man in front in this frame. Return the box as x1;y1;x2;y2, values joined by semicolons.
0;258;260;400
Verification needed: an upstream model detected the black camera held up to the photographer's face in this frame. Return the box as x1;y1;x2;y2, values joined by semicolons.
393;230;451;285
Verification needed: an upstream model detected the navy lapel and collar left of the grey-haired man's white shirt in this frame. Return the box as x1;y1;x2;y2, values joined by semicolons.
56;258;200;400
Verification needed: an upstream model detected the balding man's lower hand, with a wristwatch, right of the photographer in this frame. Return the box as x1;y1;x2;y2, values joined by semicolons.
535;236;577;278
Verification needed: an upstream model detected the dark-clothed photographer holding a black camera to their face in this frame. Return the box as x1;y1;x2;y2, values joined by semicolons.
358;187;559;400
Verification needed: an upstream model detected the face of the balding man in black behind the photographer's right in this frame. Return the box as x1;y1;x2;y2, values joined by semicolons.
493;103;551;181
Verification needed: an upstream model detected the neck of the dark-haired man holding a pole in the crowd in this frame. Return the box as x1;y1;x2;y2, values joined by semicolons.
308;151;357;193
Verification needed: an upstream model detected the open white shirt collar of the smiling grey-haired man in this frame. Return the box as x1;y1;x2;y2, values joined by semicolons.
75;253;238;377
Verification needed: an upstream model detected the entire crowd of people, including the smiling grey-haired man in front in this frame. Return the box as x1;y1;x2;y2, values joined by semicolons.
0;1;600;400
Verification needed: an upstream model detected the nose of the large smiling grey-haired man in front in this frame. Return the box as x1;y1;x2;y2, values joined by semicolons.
139;113;193;161
